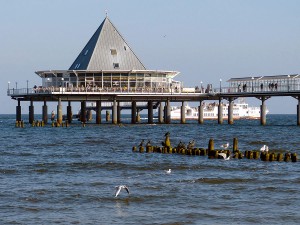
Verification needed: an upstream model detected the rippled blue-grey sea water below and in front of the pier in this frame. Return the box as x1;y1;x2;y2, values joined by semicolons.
0;114;300;225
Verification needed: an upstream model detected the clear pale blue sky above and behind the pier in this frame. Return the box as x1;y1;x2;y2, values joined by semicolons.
0;0;300;114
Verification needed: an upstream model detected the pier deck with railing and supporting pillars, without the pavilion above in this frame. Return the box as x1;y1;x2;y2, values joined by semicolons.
8;80;300;125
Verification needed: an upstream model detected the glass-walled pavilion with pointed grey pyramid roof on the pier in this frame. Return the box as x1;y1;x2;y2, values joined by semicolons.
36;17;181;92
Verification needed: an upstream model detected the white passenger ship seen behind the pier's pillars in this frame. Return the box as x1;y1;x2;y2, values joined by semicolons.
171;102;269;120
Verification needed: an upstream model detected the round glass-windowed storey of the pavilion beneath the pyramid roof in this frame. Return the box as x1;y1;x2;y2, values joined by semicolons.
38;70;181;92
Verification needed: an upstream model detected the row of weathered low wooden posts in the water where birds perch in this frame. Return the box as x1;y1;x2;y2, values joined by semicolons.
132;138;297;162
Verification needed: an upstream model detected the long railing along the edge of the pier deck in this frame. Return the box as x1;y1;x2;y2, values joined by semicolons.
7;84;300;96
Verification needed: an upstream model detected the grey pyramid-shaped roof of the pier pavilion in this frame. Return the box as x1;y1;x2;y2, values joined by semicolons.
69;17;146;70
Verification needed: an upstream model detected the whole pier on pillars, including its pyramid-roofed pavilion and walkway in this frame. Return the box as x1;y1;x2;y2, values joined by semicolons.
7;17;300;126
